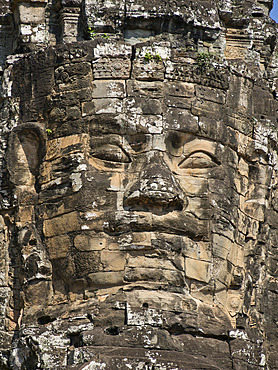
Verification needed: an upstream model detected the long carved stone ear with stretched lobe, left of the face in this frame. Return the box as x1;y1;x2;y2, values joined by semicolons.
7;123;52;316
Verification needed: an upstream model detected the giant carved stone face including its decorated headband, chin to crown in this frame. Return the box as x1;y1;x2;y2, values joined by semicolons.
7;40;271;315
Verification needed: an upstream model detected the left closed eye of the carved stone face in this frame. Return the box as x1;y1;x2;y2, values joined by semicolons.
91;144;131;163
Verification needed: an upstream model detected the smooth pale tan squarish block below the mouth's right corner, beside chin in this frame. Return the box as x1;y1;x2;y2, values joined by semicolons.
185;258;211;283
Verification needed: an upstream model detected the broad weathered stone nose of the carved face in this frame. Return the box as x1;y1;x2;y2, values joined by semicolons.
124;153;186;213
